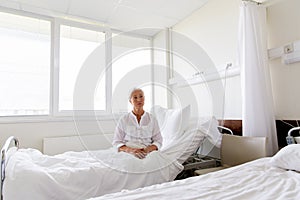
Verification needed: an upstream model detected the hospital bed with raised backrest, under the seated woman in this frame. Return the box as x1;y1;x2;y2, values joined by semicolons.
0;109;225;200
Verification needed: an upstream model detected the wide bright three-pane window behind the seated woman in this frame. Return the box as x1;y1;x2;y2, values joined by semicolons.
0;12;153;117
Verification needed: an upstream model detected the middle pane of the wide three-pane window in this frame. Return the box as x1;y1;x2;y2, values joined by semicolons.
59;25;106;111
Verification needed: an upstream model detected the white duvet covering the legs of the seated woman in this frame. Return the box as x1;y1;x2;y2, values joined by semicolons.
3;148;183;200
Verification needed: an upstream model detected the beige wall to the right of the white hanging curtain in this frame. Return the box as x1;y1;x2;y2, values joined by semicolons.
267;0;300;120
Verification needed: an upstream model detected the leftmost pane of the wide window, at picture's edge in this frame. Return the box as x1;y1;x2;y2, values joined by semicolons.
0;12;51;116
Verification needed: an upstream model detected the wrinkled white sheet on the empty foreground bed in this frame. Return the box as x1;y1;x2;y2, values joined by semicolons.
91;158;300;200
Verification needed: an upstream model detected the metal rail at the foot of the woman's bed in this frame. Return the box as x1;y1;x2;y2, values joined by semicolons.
0;136;19;200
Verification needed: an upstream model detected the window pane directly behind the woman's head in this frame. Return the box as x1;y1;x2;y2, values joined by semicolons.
112;35;152;112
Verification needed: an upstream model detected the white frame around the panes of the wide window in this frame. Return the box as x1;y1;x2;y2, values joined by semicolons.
0;7;154;124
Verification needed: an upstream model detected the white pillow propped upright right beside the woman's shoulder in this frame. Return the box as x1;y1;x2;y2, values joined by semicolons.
152;105;191;146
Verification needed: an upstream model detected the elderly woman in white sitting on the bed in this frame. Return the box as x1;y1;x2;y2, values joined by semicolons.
113;88;162;159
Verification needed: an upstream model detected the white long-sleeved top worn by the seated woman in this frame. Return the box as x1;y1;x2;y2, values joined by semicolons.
113;112;162;149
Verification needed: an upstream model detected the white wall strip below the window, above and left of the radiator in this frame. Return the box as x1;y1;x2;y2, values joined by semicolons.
0;120;116;151
